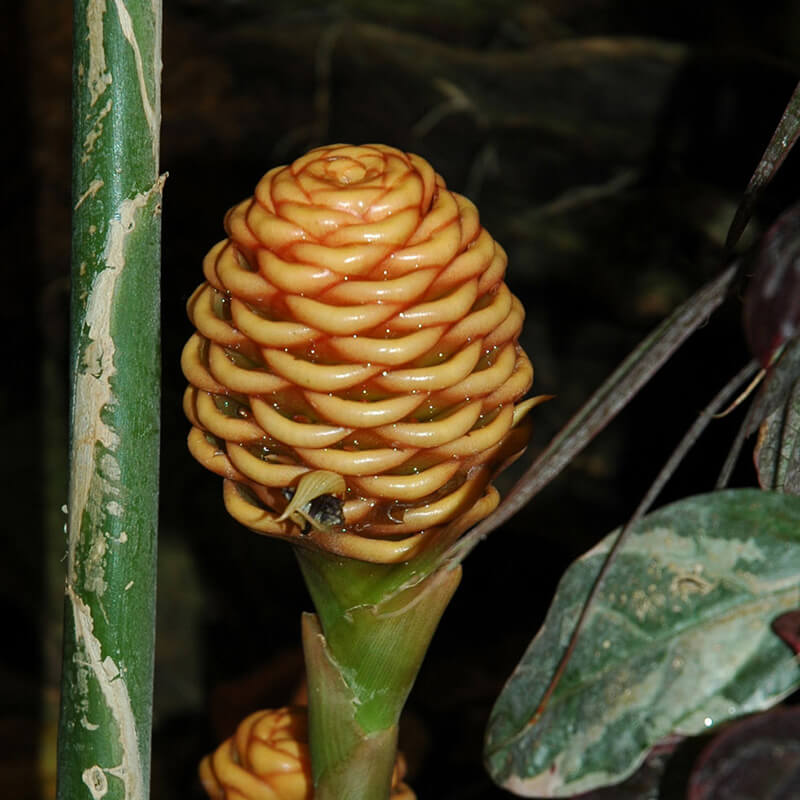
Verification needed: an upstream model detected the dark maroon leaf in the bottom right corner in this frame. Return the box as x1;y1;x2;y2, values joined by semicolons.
688;708;800;800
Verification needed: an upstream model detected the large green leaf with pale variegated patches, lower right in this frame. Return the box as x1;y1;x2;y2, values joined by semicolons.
486;489;800;797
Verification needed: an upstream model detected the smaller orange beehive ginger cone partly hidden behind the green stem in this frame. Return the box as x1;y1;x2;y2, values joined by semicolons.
200;706;416;800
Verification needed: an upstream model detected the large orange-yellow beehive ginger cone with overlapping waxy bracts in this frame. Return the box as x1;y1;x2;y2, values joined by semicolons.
182;145;536;562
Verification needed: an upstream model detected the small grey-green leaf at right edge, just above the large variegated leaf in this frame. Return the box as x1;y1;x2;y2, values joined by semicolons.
754;356;800;495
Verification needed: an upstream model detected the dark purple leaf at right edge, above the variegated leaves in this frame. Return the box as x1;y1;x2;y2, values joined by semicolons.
744;204;800;366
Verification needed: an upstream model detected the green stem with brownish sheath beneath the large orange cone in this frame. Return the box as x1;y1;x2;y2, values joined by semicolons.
297;548;461;800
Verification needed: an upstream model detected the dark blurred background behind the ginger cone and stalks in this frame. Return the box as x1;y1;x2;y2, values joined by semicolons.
0;0;800;800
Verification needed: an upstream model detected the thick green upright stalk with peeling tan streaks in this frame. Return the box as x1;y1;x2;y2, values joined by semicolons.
58;0;163;800
